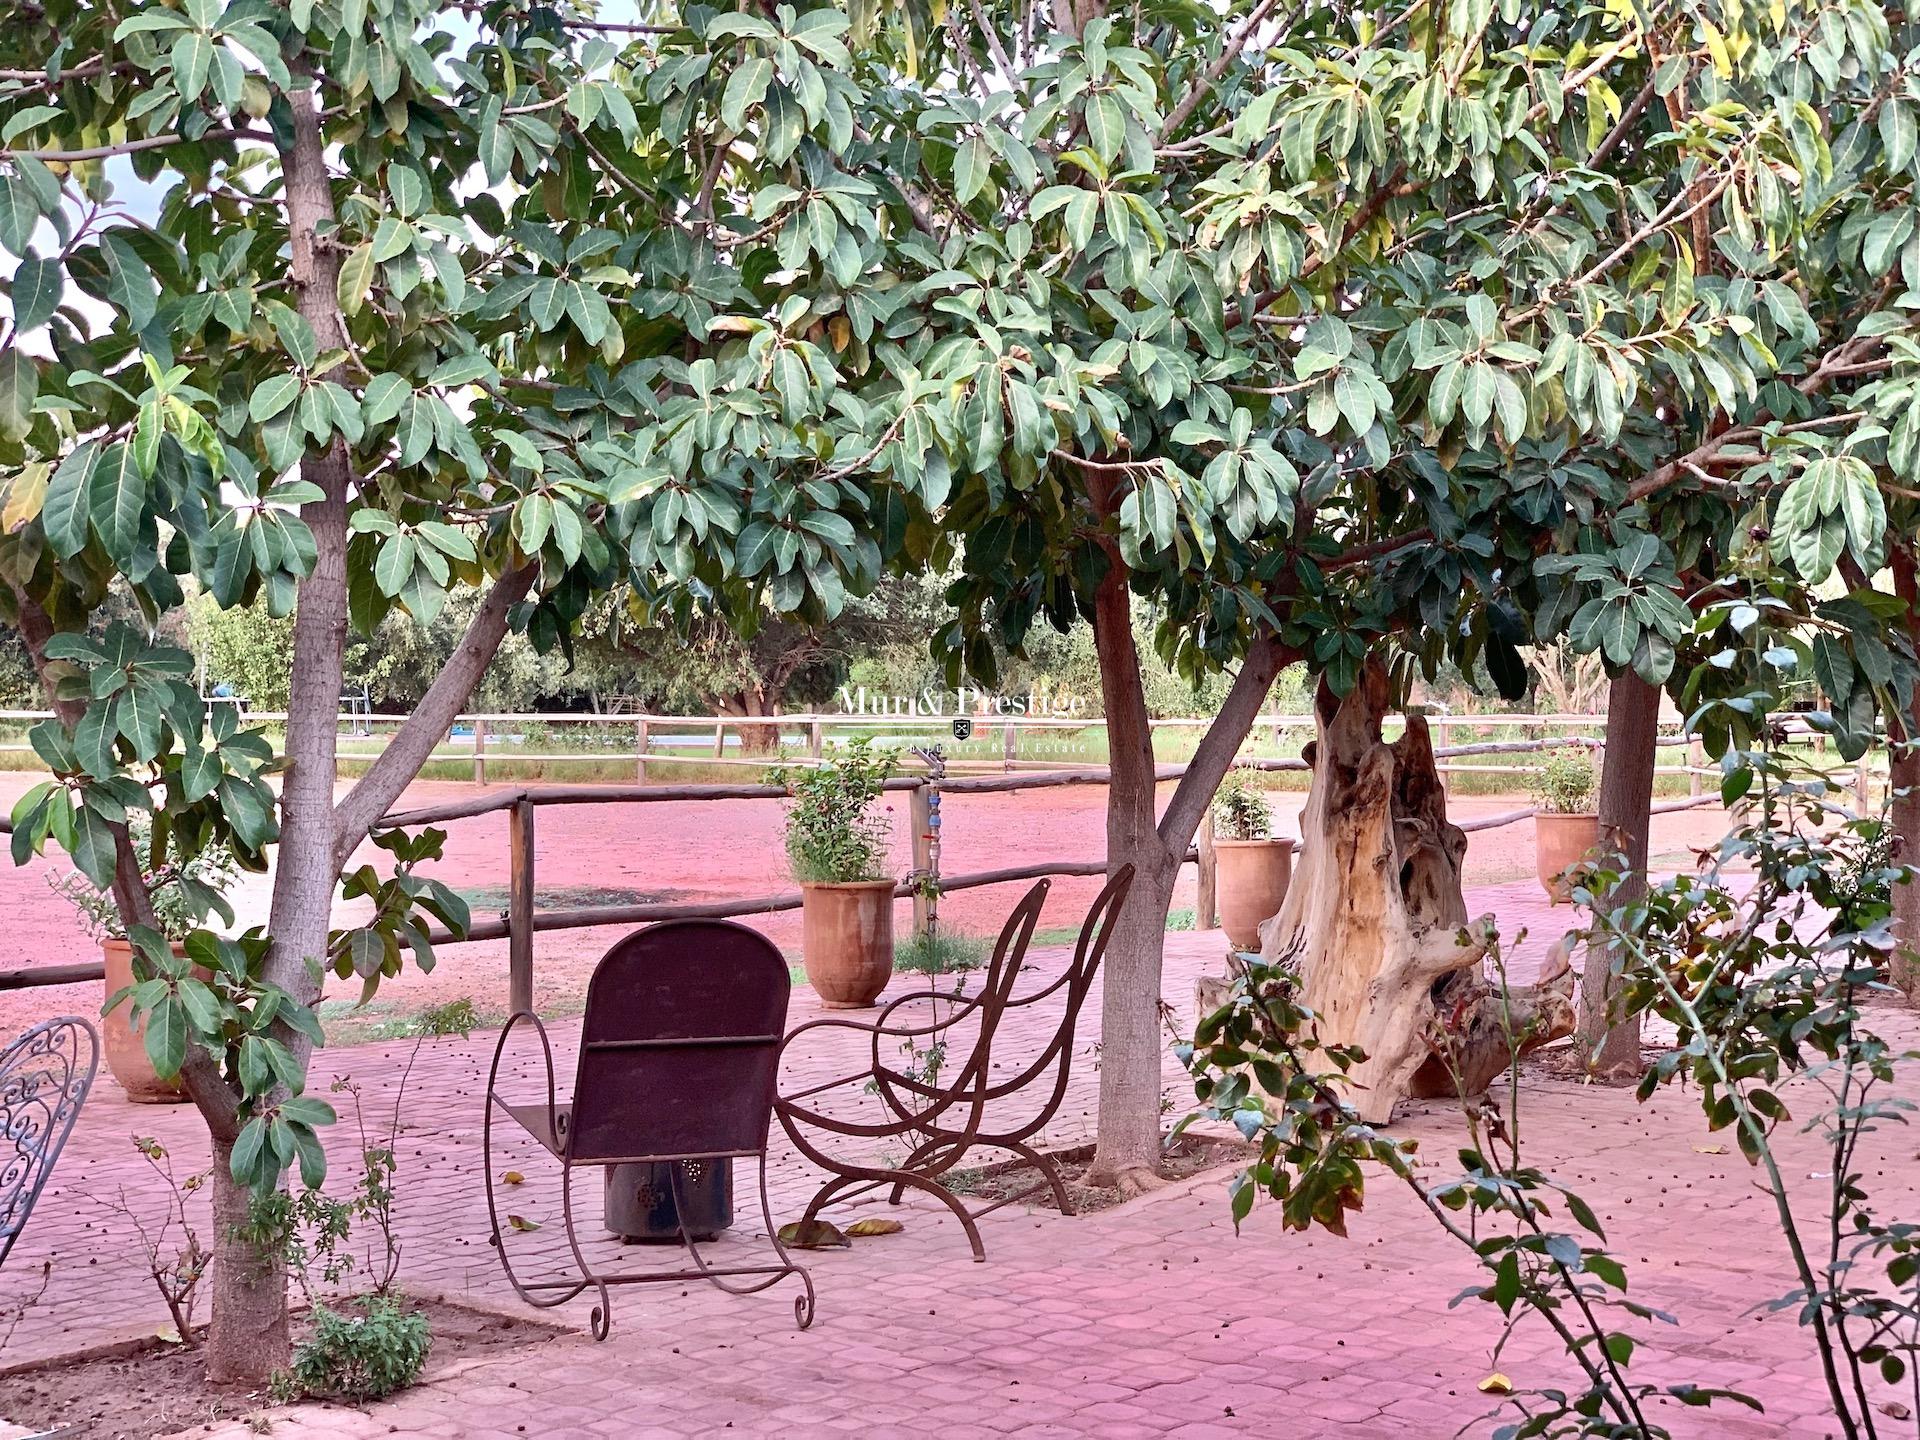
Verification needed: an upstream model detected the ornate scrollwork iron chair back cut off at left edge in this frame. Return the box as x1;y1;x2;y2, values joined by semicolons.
0;1016;100;1265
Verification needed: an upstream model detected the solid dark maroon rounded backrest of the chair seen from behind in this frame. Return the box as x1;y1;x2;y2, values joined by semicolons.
568;920;793;1164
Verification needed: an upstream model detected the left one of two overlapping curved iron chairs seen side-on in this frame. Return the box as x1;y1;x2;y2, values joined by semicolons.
774;879;1050;1260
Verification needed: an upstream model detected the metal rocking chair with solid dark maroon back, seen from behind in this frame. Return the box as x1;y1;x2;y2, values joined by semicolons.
482;920;814;1340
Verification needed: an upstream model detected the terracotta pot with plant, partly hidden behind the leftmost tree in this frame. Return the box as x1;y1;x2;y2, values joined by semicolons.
46;812;238;1104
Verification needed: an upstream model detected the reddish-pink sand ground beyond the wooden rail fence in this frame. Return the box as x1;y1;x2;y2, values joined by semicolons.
0;774;1724;1039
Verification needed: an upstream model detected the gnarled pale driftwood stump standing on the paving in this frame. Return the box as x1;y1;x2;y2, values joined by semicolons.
1261;660;1574;1125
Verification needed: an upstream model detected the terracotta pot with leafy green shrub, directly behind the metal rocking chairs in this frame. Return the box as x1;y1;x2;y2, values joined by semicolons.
774;739;893;1010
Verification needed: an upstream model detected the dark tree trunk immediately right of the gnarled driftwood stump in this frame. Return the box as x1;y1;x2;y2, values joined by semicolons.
1578;670;1661;1083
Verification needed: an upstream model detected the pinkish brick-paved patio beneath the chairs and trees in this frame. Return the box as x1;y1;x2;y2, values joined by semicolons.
0;883;1920;1440
